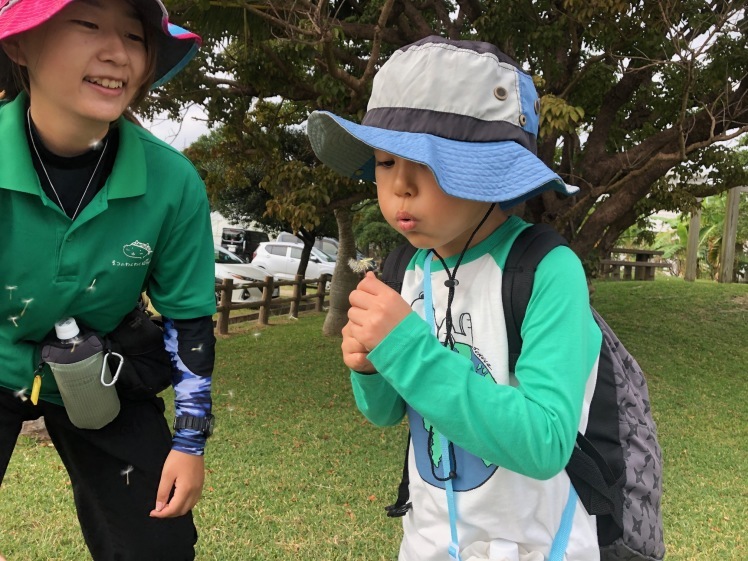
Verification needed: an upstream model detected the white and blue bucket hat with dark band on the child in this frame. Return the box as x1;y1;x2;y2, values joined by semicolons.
307;36;579;208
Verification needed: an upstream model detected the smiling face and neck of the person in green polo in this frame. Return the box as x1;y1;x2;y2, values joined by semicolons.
6;0;148;147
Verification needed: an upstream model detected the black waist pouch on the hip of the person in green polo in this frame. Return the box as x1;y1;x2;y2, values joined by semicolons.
106;306;172;399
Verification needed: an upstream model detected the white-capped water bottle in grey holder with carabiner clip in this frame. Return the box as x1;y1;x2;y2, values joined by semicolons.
41;318;122;429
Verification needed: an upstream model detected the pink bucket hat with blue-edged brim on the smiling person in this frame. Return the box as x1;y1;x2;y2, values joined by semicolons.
0;0;201;88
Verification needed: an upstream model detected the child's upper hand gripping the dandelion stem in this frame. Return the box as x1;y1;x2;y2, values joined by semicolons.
343;271;411;352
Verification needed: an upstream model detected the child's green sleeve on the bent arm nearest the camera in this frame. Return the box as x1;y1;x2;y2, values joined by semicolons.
368;247;601;479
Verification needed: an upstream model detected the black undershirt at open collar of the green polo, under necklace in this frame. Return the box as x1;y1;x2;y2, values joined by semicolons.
26;114;119;218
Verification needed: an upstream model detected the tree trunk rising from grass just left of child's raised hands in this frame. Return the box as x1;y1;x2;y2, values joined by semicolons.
322;208;361;337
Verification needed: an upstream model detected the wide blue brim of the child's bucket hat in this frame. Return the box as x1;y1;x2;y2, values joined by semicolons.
307;111;579;208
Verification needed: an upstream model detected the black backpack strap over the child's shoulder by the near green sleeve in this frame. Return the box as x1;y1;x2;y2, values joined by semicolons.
501;224;569;372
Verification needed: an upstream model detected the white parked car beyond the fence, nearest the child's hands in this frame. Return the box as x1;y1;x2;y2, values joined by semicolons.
252;241;335;280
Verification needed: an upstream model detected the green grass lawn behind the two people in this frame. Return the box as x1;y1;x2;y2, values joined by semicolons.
0;279;748;561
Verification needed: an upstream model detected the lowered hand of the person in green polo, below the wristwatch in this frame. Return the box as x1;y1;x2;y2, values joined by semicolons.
151;450;205;518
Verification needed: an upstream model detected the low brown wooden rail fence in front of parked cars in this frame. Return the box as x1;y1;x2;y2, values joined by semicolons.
215;275;331;335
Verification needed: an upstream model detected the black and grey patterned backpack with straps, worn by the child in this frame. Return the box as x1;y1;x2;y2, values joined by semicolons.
381;224;665;561
